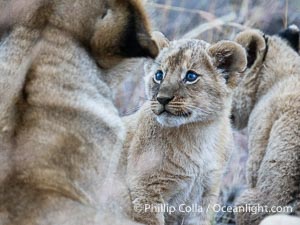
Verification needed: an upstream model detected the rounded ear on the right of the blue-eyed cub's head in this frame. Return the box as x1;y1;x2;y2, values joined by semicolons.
208;41;247;86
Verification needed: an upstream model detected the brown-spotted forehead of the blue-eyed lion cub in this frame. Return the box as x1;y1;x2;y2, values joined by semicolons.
157;39;210;66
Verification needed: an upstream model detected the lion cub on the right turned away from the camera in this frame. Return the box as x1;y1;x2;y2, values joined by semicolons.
232;30;300;225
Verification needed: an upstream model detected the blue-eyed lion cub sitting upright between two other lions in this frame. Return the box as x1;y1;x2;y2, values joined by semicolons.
124;33;246;225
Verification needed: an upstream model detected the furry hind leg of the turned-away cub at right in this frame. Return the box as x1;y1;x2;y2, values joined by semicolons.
236;113;300;225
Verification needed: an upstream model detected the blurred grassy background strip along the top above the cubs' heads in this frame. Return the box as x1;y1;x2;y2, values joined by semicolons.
148;0;300;41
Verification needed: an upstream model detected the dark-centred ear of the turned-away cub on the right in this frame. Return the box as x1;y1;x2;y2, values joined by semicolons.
235;29;267;69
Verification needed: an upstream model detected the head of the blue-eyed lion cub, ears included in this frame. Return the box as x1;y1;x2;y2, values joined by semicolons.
145;34;246;127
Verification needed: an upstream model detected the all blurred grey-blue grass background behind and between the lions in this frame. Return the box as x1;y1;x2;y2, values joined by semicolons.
116;0;300;225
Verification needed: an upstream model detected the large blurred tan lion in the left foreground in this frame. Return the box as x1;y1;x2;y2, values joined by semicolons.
0;0;158;225
